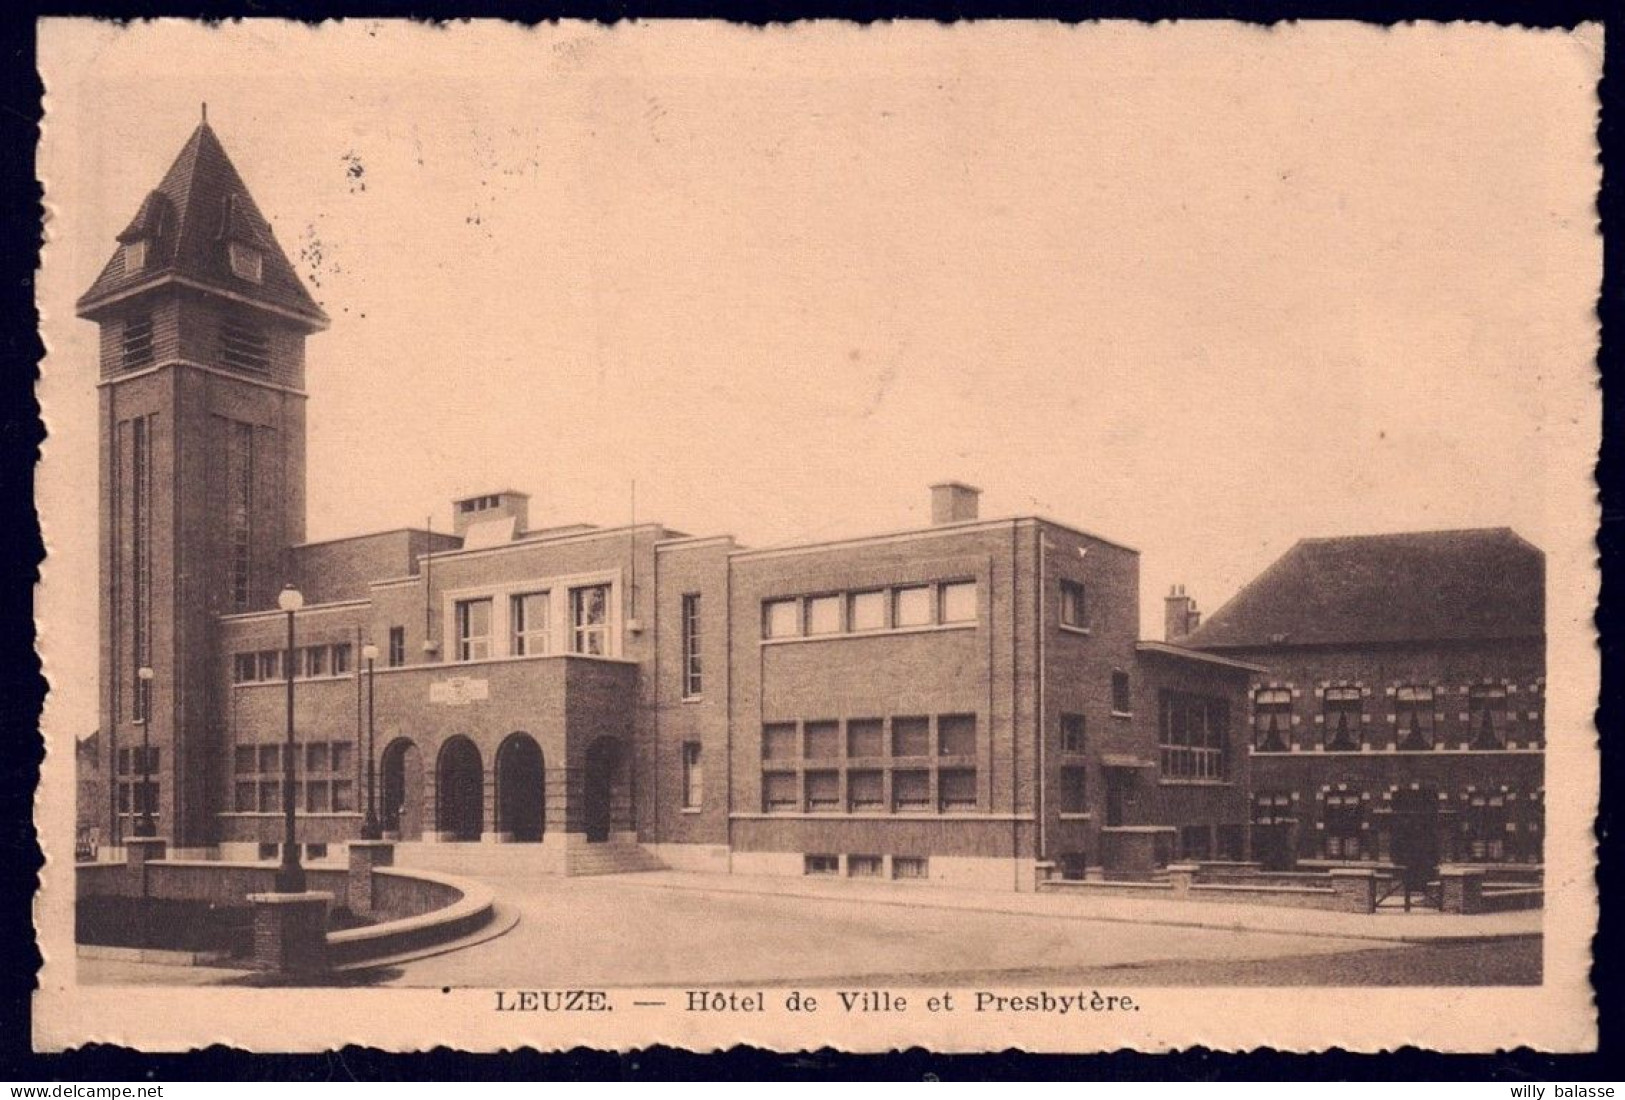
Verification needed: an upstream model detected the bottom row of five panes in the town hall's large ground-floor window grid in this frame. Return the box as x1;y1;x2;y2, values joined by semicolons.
762;767;977;814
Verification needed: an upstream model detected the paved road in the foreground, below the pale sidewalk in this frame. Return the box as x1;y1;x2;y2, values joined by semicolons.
374;876;1539;988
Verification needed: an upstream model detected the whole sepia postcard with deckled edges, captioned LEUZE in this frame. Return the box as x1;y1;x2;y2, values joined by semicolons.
34;19;1602;1051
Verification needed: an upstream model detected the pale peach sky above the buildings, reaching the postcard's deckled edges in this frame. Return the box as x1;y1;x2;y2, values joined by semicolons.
39;21;1601;733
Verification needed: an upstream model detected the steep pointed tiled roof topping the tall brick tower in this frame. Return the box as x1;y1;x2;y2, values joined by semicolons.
78;119;328;328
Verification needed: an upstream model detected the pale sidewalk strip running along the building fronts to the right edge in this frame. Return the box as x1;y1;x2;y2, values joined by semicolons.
617;871;1544;944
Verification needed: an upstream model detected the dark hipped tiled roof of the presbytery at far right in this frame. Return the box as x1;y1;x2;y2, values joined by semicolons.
1180;528;1545;648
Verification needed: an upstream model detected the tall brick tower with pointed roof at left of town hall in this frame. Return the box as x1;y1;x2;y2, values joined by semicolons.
78;112;328;851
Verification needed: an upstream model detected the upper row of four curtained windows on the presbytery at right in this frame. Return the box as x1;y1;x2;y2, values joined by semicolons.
1253;684;1534;752
